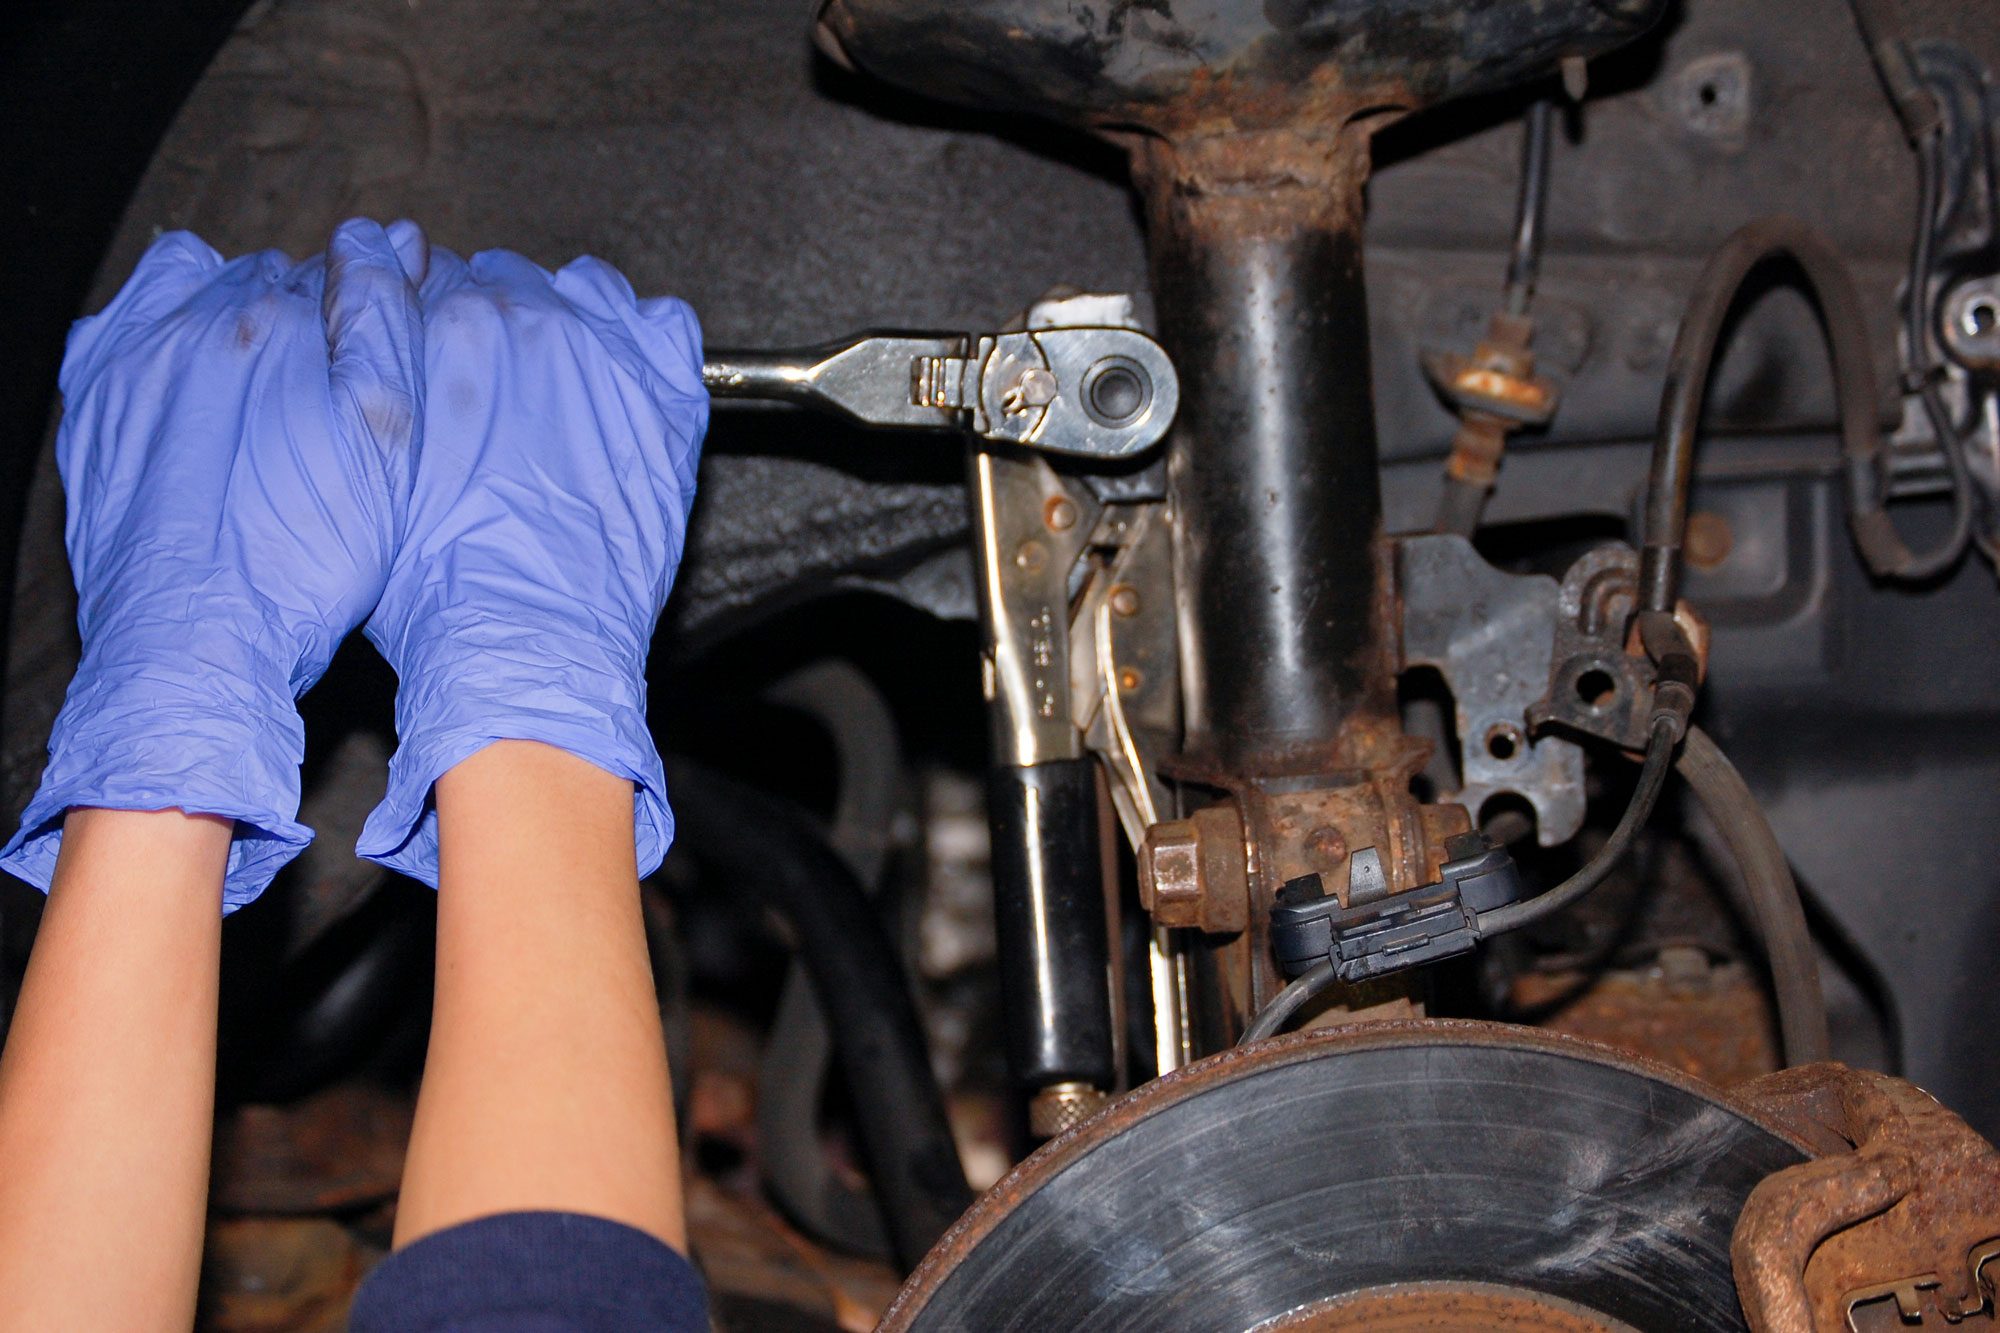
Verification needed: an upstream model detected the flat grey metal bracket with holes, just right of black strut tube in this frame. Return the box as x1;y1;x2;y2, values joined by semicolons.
1396;534;1584;847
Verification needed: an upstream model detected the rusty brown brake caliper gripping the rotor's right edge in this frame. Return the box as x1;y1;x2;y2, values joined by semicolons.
1730;1063;2000;1333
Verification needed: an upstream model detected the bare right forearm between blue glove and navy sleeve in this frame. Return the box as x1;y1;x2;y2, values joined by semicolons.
396;741;686;1249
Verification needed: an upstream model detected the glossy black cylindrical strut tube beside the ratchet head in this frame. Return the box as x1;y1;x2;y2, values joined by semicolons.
1152;198;1390;775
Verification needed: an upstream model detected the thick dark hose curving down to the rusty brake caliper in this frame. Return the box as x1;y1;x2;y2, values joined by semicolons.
1674;727;1832;1065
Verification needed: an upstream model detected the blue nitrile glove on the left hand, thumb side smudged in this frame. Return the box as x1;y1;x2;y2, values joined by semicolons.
0;220;426;909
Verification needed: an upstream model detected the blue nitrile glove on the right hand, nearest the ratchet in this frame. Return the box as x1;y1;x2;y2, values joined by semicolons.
358;250;708;887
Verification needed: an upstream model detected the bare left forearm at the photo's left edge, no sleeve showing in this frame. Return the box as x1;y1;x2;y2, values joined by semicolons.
0;811;232;1329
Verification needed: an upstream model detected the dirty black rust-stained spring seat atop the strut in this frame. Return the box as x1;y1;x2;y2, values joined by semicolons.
820;0;1666;136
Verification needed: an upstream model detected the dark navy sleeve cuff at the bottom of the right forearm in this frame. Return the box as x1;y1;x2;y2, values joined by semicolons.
348;1213;708;1333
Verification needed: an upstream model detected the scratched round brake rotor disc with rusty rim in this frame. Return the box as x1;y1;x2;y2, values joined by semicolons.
882;1023;1806;1333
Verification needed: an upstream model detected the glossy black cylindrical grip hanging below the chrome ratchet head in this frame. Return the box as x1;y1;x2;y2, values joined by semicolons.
988;759;1118;1089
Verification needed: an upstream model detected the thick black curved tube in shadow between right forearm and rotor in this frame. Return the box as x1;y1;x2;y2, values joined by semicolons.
668;763;972;1269
